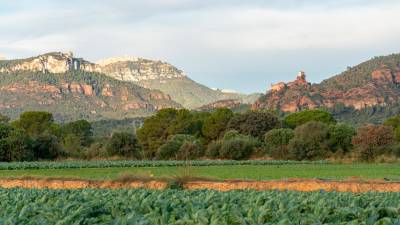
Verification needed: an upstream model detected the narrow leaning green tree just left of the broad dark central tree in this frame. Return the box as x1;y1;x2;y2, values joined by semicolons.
202;108;233;143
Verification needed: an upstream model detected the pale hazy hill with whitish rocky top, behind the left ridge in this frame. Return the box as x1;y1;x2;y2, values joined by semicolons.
97;57;260;109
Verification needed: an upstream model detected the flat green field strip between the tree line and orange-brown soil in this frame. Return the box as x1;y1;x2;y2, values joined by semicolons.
0;161;400;181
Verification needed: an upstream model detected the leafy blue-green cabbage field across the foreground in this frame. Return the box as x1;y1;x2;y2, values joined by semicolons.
0;189;400;225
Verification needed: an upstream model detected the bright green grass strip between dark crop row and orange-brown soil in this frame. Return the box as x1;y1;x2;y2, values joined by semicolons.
0;164;400;180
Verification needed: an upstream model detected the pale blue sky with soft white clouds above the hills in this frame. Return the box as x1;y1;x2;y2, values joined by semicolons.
0;0;400;93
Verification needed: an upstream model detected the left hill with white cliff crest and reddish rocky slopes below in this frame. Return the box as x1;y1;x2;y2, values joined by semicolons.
0;52;182;121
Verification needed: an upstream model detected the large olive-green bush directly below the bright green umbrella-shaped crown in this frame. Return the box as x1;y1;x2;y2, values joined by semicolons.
288;121;329;160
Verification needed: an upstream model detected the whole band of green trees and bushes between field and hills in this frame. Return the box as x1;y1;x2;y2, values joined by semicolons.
0;109;400;162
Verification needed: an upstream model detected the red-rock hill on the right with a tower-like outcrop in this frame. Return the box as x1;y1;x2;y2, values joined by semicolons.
252;54;400;123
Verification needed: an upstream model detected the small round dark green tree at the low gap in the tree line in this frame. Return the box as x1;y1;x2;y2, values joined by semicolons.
107;132;142;159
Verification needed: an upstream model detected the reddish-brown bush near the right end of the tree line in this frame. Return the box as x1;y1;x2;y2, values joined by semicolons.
352;125;395;161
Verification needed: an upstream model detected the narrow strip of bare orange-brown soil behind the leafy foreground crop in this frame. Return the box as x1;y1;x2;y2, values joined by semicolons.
0;178;400;192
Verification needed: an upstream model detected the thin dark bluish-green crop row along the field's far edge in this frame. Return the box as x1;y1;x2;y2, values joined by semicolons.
0;160;328;170
